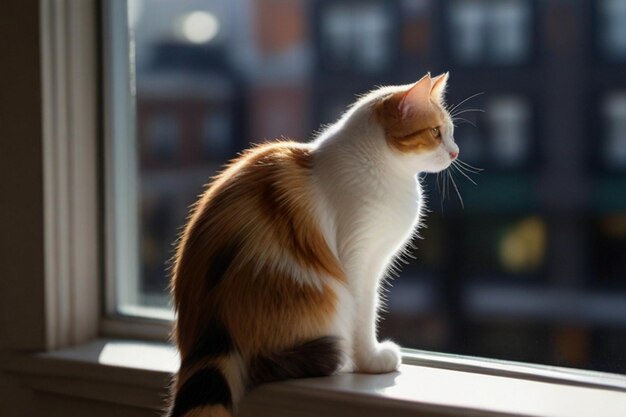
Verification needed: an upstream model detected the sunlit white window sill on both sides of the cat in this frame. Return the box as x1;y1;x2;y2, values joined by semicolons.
3;339;626;417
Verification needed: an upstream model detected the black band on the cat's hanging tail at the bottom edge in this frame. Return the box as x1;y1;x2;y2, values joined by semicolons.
169;368;232;417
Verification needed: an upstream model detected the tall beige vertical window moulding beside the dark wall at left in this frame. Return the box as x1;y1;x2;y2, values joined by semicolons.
39;0;101;350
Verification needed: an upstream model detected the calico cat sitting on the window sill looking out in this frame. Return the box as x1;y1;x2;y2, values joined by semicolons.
168;73;459;417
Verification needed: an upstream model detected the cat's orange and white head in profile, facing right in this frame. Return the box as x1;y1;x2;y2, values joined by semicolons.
375;73;459;172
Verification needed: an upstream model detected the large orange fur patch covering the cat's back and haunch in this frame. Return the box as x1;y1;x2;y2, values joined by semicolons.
172;142;346;364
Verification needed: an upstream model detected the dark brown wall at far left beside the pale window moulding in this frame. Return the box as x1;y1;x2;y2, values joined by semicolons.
0;0;45;417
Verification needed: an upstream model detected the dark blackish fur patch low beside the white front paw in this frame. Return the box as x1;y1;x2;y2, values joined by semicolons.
249;336;343;385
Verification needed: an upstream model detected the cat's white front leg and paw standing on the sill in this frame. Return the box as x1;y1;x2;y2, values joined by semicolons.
353;289;402;374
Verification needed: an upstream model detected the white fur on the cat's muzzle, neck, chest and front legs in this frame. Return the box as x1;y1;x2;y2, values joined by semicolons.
312;85;458;373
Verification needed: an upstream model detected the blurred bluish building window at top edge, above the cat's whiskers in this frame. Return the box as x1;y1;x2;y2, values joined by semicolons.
448;0;532;65
